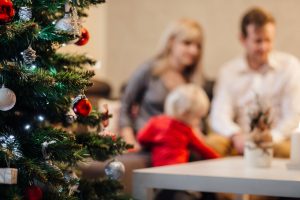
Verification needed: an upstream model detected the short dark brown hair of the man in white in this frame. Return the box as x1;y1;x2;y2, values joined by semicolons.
241;7;275;37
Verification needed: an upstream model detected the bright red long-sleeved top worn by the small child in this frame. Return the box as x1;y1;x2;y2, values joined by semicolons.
137;115;220;166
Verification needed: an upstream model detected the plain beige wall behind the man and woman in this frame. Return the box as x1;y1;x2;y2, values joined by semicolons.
62;0;300;97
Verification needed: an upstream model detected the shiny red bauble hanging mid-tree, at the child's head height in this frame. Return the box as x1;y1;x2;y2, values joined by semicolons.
72;95;92;117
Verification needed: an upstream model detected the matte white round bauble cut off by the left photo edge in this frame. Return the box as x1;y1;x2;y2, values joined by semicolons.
0;85;17;111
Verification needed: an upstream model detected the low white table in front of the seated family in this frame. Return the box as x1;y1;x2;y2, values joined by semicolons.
133;157;300;200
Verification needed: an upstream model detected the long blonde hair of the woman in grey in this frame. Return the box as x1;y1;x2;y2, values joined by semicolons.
154;19;203;82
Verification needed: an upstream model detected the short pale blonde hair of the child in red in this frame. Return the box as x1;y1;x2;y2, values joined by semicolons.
165;84;209;118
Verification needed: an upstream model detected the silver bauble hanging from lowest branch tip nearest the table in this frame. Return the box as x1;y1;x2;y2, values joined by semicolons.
104;160;125;180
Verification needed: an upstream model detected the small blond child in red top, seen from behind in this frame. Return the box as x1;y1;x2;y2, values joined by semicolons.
138;84;220;166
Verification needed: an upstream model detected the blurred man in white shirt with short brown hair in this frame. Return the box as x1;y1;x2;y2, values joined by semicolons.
211;8;300;157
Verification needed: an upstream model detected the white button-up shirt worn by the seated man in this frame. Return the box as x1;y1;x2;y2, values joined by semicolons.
210;52;300;142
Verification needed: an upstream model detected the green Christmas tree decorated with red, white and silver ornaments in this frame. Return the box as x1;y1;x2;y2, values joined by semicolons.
0;0;128;200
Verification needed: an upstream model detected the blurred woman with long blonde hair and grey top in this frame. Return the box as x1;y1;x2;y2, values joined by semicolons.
120;19;203;151
